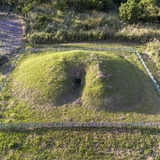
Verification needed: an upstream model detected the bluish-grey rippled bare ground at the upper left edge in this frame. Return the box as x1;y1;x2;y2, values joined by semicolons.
0;15;23;55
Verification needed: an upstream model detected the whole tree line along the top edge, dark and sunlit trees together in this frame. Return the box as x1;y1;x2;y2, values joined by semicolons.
0;0;160;23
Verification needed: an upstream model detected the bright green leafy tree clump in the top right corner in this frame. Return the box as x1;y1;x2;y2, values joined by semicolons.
119;0;160;23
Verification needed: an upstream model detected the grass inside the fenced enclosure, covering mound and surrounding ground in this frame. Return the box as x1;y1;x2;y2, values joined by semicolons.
1;43;160;123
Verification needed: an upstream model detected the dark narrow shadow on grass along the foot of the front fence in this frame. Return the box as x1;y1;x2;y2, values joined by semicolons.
0;127;160;135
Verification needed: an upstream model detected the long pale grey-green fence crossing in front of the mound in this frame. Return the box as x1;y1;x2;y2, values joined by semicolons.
0;122;160;129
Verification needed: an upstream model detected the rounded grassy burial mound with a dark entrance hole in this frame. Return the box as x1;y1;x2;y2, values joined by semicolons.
11;50;143;111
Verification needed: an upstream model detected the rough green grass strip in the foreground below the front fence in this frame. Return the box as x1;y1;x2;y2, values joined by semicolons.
0;128;160;160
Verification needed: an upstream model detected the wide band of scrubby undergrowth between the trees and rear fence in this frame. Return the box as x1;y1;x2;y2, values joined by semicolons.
25;4;160;44
